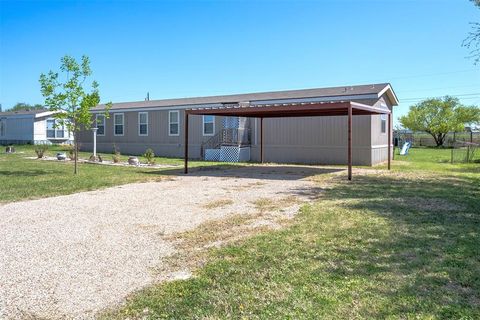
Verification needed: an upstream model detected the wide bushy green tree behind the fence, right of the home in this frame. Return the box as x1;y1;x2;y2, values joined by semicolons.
400;96;480;146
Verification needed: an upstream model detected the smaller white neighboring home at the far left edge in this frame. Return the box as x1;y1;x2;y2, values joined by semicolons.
0;110;73;145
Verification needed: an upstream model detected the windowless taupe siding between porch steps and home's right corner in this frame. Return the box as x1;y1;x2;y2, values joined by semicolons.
251;116;371;165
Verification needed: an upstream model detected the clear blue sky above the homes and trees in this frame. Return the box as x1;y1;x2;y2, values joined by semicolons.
0;0;480;124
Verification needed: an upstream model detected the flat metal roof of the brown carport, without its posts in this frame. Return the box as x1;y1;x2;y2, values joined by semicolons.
185;101;390;118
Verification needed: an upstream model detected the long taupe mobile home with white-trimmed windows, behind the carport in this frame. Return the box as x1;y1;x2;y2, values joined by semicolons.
79;83;398;165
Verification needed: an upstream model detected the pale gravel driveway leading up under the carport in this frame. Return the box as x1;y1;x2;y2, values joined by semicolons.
0;166;332;319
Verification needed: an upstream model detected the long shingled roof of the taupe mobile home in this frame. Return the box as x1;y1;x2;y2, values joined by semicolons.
93;83;397;111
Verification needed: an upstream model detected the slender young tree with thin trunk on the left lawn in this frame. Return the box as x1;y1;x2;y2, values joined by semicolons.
40;55;111;174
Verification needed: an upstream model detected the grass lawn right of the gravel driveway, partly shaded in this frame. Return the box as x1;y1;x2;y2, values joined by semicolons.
103;149;480;319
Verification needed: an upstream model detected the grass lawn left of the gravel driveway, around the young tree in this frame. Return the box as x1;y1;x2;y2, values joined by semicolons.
0;145;221;202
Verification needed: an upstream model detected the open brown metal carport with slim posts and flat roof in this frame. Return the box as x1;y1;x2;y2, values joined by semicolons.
184;101;392;180
